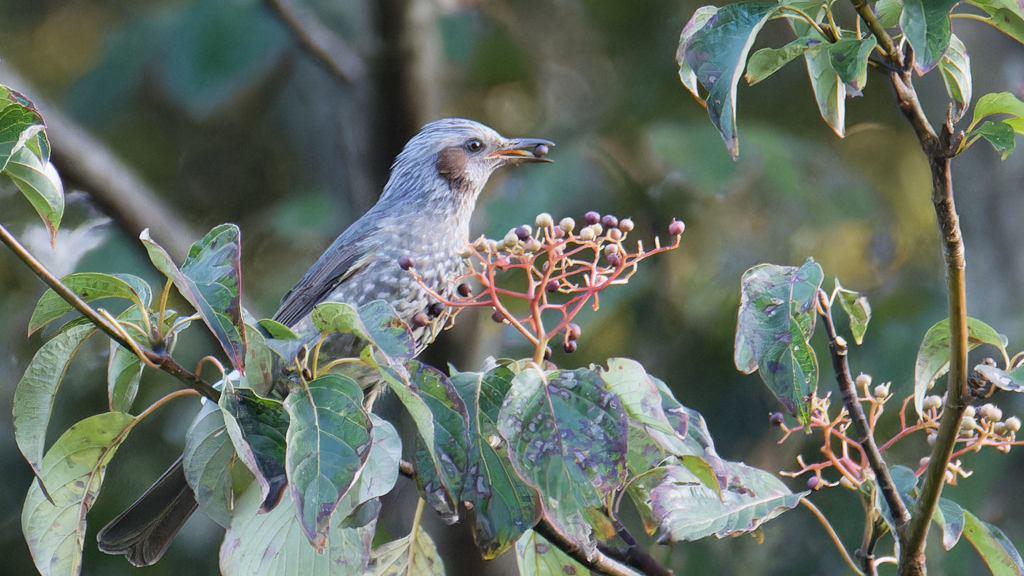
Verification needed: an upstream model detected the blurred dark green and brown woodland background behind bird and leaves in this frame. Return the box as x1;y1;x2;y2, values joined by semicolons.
0;0;1024;575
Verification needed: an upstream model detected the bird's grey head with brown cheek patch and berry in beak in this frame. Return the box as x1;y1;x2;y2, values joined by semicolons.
381;118;555;212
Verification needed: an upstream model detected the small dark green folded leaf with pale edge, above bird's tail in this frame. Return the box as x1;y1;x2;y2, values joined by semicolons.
220;379;289;509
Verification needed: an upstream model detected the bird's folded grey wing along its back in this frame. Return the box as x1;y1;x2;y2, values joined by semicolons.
273;231;376;326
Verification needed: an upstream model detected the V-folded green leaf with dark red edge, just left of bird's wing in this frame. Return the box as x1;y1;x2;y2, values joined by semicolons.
139;224;246;372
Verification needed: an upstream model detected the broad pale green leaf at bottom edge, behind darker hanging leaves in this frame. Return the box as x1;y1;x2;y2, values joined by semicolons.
220;485;377;576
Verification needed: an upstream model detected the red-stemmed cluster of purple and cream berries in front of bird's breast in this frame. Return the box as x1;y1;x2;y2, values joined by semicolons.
410;212;685;363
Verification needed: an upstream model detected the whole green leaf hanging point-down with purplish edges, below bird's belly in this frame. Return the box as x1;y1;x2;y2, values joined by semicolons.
285;374;372;551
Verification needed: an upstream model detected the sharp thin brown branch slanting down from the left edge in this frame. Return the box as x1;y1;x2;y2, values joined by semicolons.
0;224;220;402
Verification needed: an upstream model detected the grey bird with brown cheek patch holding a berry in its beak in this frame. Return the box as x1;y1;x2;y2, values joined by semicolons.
96;118;554;567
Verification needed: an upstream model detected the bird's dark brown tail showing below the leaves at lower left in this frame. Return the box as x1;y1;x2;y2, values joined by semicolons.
96;457;199;566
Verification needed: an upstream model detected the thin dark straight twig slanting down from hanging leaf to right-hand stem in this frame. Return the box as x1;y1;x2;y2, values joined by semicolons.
818;290;910;531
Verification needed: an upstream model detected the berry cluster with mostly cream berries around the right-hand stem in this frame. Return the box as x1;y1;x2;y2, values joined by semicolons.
770;374;1024;490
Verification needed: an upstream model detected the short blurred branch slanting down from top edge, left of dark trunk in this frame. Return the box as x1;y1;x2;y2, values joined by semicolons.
265;0;367;84
